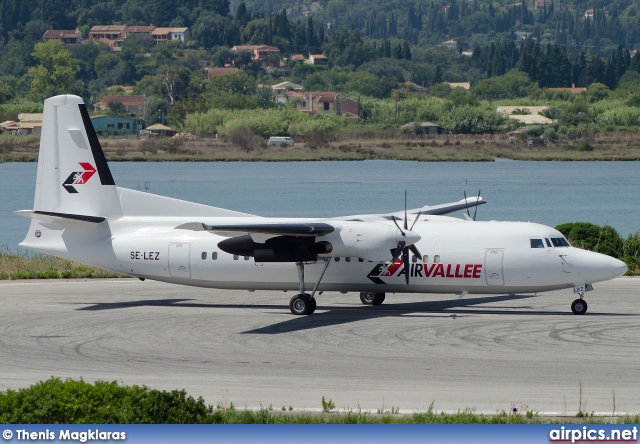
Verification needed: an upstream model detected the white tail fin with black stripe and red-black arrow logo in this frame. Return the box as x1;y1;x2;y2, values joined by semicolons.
33;95;121;217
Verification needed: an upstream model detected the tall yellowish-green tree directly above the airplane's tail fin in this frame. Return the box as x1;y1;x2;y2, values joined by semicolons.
28;40;80;100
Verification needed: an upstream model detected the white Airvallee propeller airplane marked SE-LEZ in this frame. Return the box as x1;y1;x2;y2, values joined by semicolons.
16;96;627;315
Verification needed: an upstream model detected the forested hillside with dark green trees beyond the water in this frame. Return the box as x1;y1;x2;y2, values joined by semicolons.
0;0;640;140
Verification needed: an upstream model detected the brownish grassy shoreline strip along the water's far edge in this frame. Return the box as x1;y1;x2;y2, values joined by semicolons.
0;133;640;163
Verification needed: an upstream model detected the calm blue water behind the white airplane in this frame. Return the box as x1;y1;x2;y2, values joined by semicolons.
0;160;640;250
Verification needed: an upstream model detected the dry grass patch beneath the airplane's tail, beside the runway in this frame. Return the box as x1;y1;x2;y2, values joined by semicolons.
0;247;129;280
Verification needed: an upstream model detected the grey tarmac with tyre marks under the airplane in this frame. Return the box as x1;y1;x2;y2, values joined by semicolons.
0;277;640;415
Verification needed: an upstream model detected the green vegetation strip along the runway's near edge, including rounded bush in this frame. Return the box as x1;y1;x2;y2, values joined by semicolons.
0;378;640;424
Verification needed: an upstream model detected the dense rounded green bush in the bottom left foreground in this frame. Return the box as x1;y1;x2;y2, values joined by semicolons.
0;378;212;424
